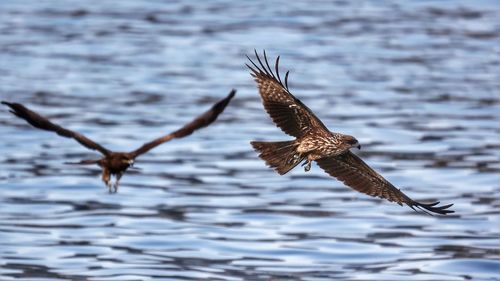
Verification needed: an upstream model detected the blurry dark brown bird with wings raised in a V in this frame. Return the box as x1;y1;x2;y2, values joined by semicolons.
2;89;236;193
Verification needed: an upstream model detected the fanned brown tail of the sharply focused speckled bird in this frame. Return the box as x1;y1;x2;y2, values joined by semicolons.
250;141;305;175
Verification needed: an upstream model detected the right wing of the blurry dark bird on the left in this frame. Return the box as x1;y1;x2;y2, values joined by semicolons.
129;89;236;158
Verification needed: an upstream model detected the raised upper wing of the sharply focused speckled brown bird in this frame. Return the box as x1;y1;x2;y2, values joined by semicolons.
247;51;327;138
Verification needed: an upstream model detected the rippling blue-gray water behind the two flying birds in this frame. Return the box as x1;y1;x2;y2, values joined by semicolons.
0;0;500;281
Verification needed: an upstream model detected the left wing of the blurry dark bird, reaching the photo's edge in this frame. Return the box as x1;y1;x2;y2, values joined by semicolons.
2;101;110;155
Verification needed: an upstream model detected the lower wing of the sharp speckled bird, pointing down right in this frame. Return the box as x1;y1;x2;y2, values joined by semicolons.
316;151;454;215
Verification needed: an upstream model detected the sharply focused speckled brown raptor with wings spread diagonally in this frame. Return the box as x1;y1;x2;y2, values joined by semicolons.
246;51;454;215
